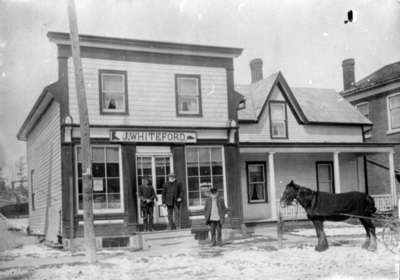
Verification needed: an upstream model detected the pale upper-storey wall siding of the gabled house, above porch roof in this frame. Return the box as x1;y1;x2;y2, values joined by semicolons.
239;88;362;142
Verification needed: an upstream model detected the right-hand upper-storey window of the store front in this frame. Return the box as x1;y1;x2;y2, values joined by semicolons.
175;74;202;116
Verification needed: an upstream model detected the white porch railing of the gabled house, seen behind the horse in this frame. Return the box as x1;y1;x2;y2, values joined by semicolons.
278;194;394;220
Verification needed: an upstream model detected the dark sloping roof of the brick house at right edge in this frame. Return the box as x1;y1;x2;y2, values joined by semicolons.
342;61;400;95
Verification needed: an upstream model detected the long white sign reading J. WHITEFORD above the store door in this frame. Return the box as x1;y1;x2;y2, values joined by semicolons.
110;130;197;143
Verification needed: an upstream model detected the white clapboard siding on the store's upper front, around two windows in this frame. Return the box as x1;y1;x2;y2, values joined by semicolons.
68;58;228;126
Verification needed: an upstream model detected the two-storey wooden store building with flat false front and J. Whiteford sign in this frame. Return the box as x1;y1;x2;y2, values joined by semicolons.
18;32;242;246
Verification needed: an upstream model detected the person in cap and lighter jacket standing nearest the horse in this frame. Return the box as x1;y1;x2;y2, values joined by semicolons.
204;186;225;246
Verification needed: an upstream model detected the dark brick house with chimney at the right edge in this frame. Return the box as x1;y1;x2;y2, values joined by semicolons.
341;58;400;199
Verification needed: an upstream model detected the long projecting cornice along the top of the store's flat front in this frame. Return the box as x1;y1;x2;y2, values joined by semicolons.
47;32;243;57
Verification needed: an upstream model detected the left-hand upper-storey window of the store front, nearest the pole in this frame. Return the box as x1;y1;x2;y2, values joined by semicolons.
99;70;128;114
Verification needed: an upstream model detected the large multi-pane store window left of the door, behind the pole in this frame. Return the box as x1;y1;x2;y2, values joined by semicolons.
76;146;123;211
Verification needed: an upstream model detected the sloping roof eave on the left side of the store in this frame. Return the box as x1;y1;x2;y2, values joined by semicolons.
17;82;57;141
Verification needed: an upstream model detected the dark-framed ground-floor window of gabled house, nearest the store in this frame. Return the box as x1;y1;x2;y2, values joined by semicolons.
247;162;267;203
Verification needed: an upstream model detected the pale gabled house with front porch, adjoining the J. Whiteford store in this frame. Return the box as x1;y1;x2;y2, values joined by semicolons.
236;59;396;224
